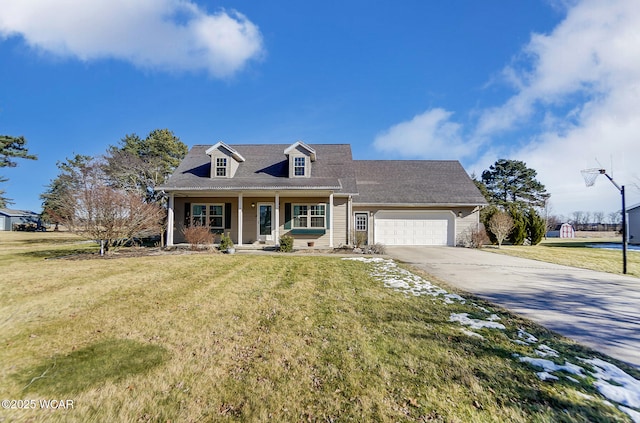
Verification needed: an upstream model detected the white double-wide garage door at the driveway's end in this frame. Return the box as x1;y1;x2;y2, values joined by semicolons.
374;211;454;246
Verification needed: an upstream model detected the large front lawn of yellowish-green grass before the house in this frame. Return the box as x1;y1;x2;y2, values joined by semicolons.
0;233;640;422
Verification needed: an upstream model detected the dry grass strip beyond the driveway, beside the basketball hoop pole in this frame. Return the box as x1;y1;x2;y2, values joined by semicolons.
487;238;640;277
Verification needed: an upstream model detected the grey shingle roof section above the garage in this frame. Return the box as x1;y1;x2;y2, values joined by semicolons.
353;160;487;205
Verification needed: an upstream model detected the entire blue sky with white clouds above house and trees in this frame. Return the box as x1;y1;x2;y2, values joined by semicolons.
0;0;640;216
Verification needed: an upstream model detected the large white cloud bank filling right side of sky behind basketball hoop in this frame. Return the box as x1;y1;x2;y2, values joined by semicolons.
376;0;640;215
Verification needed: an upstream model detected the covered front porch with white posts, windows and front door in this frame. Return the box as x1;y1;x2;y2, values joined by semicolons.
162;190;348;248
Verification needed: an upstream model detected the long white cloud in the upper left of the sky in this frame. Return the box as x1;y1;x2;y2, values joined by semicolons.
0;0;263;77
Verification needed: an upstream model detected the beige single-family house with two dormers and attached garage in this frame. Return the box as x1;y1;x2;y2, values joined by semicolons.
156;141;486;247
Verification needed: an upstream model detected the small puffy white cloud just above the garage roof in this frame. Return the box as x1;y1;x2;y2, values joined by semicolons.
374;109;469;159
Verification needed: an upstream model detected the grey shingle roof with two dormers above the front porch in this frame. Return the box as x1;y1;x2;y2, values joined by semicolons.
156;144;356;194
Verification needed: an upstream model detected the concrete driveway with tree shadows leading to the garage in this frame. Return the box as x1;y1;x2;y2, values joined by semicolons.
387;247;640;368
